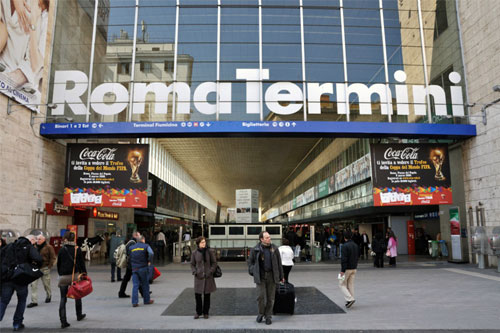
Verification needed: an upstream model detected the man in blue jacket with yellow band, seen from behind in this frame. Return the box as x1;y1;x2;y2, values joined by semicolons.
128;235;154;308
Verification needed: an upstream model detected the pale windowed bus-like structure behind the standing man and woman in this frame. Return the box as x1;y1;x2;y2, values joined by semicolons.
208;223;283;260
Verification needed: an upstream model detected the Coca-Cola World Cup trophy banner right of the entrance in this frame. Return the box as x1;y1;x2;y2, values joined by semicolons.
370;143;453;206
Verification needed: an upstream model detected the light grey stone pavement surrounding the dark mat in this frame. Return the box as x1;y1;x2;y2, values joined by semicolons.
0;256;500;333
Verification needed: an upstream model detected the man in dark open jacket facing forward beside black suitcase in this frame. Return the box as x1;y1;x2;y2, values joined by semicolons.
248;231;285;325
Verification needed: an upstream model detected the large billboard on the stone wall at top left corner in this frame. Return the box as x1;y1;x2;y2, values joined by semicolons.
0;1;49;111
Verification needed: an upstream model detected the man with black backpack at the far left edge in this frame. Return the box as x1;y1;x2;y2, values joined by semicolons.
0;235;43;331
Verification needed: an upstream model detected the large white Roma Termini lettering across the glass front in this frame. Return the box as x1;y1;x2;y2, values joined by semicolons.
52;68;464;117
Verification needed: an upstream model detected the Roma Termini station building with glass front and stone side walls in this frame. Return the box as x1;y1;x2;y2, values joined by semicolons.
0;0;500;266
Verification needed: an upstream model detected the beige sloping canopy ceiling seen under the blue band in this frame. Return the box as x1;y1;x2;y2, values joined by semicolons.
155;138;320;207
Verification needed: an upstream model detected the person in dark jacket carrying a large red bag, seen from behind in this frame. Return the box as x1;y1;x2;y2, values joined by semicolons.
57;231;87;328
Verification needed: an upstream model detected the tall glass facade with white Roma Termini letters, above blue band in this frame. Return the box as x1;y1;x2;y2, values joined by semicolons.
49;0;466;122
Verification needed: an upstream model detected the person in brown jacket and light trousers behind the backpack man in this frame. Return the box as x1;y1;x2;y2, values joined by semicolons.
27;235;56;308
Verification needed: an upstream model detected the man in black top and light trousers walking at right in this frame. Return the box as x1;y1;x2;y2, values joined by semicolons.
339;230;359;309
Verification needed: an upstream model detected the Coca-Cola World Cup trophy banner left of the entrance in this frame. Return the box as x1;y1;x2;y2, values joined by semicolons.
64;144;149;208
